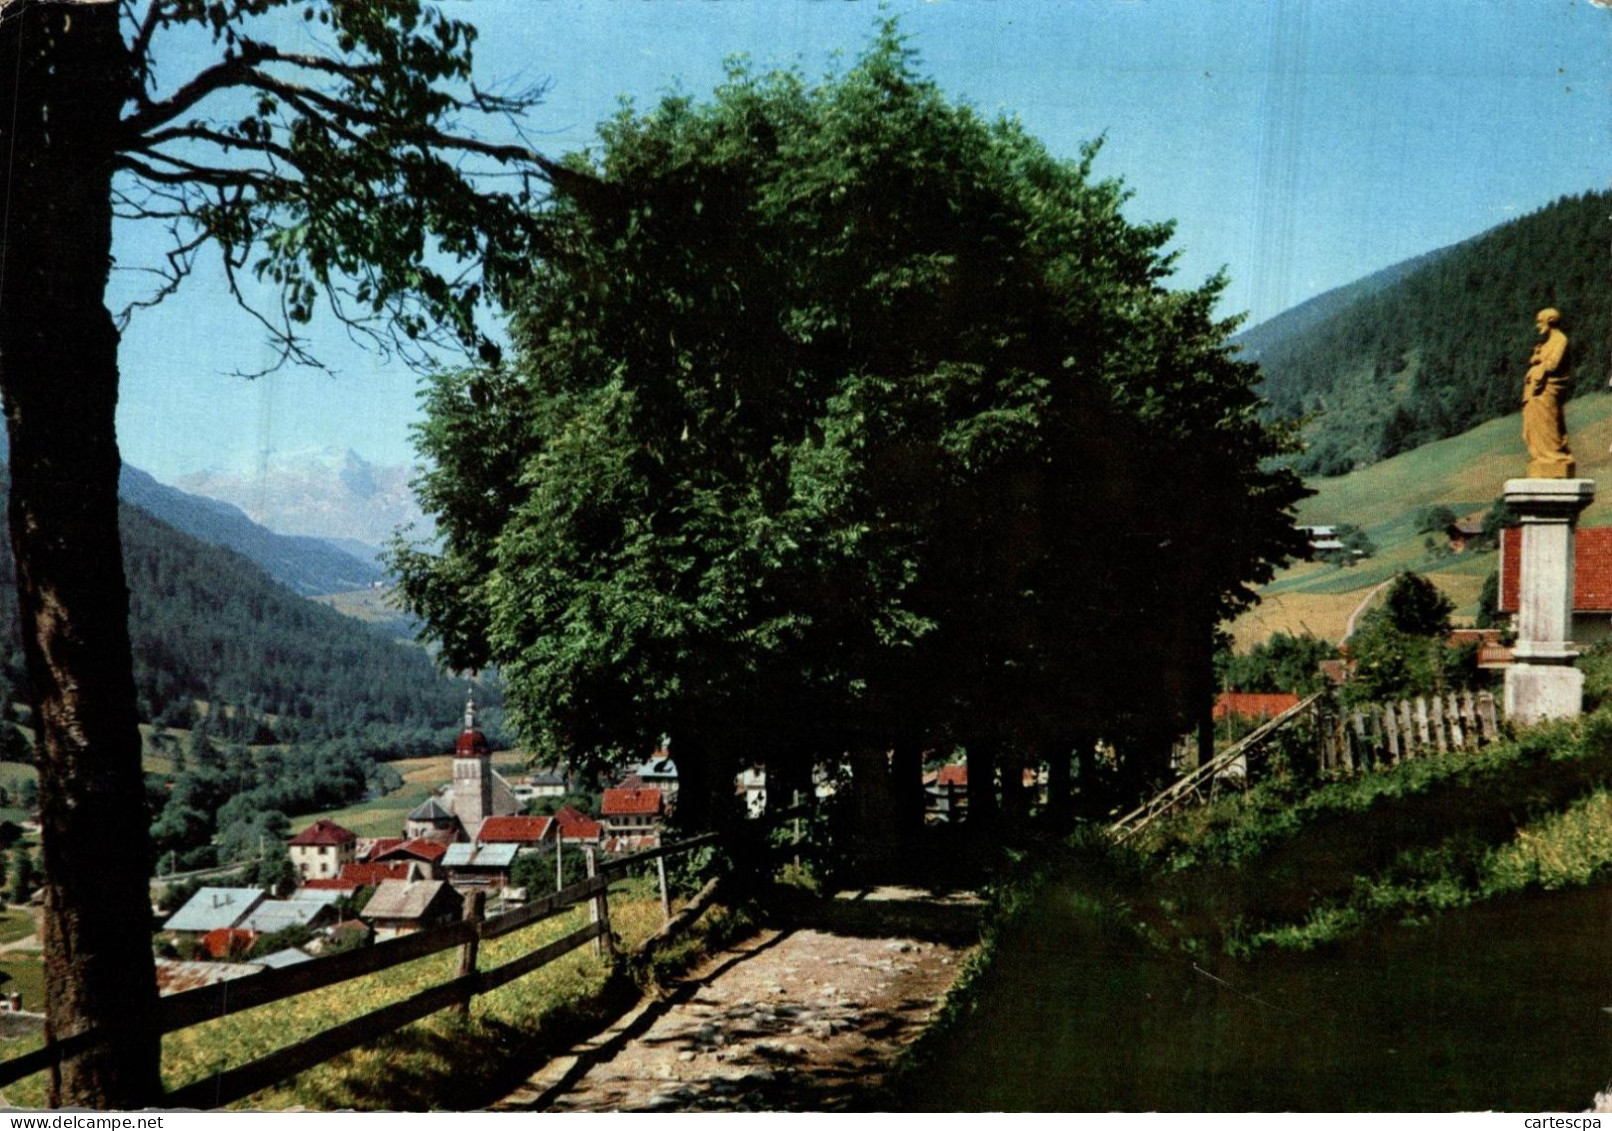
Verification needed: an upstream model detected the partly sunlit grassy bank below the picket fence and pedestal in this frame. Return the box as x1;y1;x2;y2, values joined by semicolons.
1136;711;1612;954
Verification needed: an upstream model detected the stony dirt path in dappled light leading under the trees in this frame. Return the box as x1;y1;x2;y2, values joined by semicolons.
493;888;980;1112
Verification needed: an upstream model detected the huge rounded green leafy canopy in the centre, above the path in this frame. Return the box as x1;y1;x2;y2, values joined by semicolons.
397;26;1302;818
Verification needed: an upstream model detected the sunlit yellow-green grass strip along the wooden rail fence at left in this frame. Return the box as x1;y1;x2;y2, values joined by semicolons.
6;878;686;1112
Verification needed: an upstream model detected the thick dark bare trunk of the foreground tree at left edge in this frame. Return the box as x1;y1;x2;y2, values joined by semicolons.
0;0;161;1108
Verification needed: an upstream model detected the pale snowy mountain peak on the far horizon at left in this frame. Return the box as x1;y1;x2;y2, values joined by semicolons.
174;448;429;547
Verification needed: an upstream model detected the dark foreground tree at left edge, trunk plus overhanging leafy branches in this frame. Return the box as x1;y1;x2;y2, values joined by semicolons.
0;0;573;1107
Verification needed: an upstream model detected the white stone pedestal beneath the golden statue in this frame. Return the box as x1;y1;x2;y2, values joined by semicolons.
1506;479;1596;727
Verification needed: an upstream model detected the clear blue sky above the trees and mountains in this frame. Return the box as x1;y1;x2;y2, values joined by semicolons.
114;0;1612;480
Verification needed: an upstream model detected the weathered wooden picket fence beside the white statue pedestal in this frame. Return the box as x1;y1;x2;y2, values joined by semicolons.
1317;691;1501;777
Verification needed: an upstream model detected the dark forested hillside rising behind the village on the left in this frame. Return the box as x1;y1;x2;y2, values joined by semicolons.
0;480;496;754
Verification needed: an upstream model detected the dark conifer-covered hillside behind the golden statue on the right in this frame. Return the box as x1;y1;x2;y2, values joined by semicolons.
1249;192;1612;475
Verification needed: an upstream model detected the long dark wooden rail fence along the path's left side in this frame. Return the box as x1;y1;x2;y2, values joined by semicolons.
0;833;717;1108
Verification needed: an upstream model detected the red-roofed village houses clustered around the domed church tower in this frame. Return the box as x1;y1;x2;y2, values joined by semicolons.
141;702;980;1012
